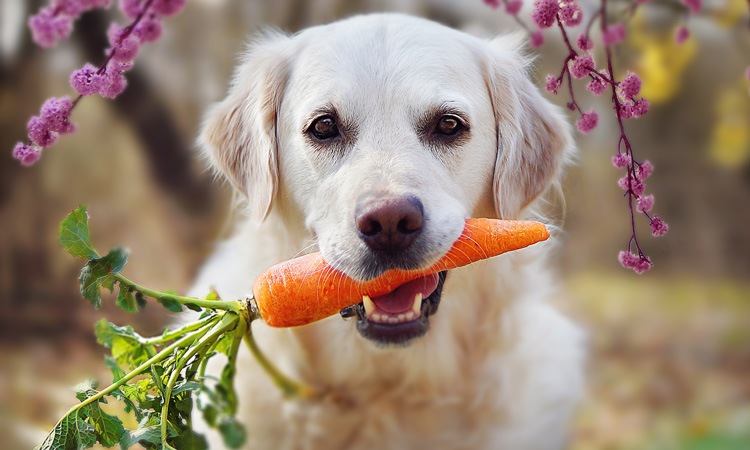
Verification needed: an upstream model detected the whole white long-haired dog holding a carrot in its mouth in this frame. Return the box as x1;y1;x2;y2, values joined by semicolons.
192;14;585;450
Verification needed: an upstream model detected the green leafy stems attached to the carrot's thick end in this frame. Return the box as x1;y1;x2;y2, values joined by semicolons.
37;207;249;450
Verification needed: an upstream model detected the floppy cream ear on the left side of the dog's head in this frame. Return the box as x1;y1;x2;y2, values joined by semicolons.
199;32;291;219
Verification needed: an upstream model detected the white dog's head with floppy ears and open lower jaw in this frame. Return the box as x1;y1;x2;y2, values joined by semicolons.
202;15;569;344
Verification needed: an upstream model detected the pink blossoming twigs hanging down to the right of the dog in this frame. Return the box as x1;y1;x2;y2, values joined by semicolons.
484;0;680;274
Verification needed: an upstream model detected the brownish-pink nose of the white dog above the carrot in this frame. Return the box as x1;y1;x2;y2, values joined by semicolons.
355;197;424;253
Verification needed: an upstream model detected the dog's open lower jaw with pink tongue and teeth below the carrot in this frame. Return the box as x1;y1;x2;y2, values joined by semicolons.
341;271;448;345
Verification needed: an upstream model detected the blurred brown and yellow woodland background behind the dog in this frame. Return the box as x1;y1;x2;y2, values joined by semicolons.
0;0;750;450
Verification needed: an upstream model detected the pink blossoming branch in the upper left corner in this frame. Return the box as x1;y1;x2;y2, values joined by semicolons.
13;0;185;166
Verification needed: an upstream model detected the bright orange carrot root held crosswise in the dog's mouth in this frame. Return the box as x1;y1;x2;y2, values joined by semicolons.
253;219;549;327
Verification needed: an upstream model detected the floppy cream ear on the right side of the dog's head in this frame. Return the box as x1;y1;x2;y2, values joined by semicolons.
488;36;572;219
